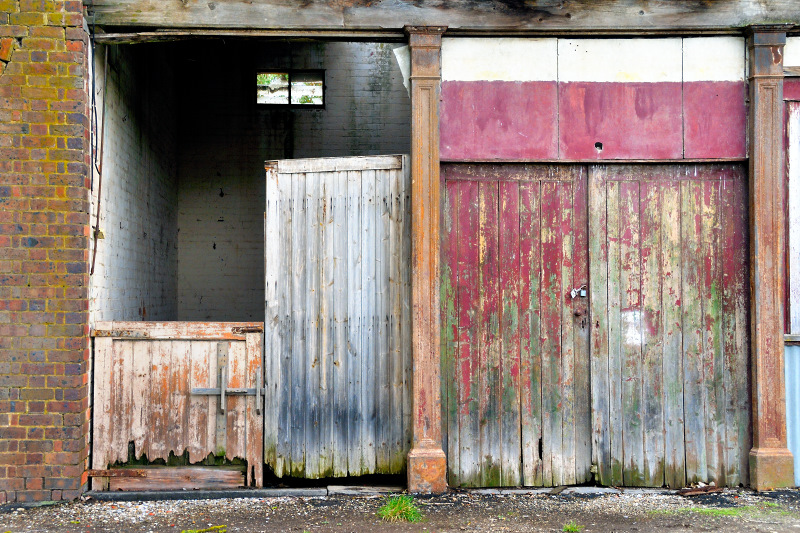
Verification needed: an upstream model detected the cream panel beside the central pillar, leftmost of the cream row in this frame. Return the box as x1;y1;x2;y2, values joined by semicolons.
442;38;558;81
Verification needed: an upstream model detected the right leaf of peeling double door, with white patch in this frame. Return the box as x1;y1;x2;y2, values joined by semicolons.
589;165;751;487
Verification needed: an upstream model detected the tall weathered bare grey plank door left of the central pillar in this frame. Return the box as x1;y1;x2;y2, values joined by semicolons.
264;156;411;478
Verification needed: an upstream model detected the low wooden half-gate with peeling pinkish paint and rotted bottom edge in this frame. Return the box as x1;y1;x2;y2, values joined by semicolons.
92;322;263;490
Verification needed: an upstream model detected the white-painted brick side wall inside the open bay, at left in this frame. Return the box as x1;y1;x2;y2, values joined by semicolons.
90;46;178;322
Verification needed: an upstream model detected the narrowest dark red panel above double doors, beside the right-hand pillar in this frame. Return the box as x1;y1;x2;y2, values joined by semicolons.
683;81;747;158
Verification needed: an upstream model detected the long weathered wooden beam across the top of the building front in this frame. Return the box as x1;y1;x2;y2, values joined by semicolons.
84;0;800;31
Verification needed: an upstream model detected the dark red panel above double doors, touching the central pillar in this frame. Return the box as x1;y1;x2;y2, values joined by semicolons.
440;81;558;160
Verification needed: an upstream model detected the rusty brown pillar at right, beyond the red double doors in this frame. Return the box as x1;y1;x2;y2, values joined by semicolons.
748;25;794;490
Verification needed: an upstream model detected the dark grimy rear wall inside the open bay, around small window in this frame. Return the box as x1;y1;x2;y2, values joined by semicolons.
178;42;411;321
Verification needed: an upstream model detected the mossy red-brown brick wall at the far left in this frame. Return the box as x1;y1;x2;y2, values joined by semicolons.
0;0;89;504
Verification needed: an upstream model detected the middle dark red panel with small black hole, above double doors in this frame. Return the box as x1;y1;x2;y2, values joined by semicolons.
558;82;683;159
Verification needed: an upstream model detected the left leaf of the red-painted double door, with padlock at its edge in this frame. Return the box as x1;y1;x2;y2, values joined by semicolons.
442;164;591;486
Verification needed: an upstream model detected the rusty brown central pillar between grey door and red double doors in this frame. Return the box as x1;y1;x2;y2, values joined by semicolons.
406;26;447;493
